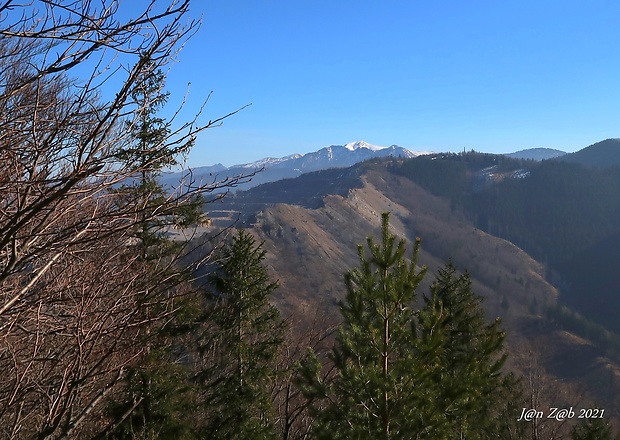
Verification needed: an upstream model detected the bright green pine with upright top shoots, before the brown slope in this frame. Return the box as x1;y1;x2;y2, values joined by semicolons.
302;214;445;439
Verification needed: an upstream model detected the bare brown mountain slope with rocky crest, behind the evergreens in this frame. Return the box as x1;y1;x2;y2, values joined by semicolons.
203;162;620;429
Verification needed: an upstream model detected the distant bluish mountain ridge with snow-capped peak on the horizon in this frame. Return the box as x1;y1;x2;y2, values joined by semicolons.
160;141;431;190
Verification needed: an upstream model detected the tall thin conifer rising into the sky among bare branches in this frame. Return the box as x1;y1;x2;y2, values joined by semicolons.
107;57;203;439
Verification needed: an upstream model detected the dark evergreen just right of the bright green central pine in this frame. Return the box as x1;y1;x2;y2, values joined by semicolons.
420;263;517;439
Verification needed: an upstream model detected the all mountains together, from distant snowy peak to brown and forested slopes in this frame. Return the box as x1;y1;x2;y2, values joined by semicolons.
186;140;620;438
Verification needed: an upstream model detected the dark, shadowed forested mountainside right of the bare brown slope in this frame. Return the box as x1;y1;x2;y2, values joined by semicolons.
391;153;620;331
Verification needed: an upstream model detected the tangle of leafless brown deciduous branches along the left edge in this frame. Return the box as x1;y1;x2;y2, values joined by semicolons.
0;0;249;439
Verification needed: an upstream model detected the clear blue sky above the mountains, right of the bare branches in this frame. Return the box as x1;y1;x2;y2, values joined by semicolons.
155;0;620;166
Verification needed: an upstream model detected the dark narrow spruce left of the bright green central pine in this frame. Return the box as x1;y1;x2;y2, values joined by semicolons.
196;230;284;440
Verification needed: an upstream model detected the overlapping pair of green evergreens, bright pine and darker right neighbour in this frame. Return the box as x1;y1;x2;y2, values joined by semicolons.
300;214;515;439
